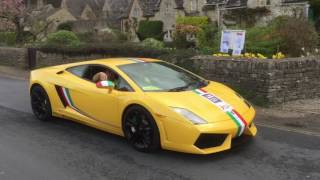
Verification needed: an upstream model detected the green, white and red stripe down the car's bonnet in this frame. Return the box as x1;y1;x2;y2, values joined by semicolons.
194;89;248;136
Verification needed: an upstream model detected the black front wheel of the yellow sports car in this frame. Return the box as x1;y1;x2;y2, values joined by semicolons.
122;106;160;152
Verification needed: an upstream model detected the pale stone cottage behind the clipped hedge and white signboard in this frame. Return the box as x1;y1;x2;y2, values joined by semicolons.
121;0;309;41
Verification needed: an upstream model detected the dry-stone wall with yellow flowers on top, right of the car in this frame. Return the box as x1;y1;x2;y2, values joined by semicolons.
192;56;320;104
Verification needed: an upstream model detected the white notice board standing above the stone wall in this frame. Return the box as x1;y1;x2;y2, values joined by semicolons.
220;30;246;55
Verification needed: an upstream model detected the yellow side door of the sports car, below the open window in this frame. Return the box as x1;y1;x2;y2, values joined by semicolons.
63;65;132;128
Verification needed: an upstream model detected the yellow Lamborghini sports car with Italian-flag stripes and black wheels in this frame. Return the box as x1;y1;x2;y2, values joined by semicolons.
30;58;257;154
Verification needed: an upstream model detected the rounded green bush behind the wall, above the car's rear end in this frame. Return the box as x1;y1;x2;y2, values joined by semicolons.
45;30;80;47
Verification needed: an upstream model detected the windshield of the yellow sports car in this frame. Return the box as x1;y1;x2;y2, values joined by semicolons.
119;62;208;92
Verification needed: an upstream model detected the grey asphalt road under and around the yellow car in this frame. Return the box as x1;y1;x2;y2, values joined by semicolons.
0;77;320;180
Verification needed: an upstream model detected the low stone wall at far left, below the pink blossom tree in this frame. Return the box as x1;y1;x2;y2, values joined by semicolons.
0;47;28;69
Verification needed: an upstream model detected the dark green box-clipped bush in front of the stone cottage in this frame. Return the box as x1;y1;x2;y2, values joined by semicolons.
137;20;163;41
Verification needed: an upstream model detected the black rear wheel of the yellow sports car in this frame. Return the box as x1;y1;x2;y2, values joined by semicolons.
30;85;52;121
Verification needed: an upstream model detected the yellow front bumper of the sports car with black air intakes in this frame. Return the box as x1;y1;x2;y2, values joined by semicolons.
161;108;257;154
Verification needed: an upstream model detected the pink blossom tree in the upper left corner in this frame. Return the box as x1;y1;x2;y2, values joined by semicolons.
0;0;26;43
